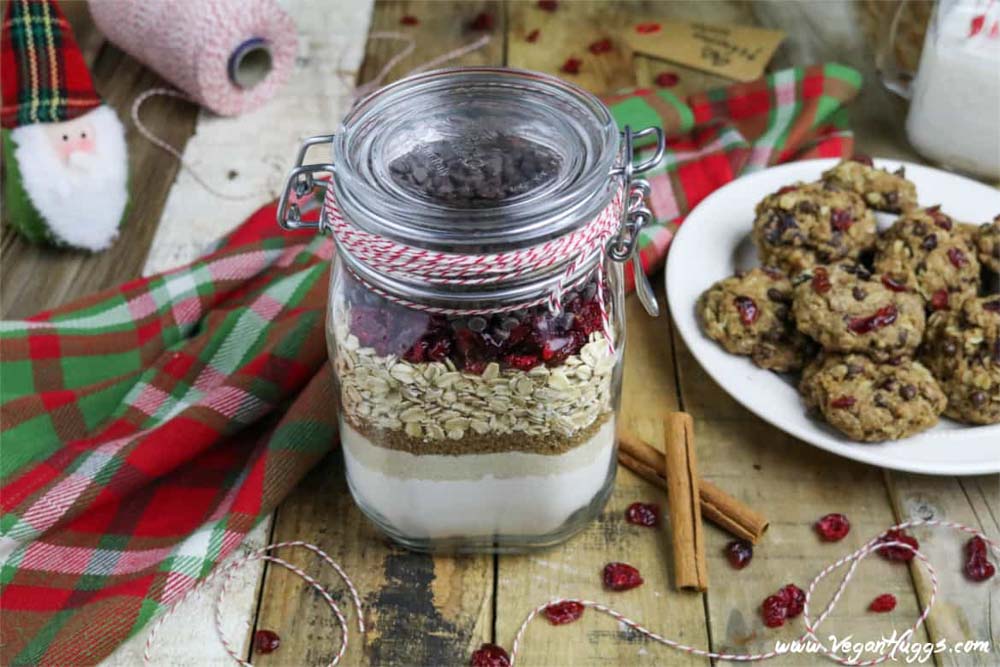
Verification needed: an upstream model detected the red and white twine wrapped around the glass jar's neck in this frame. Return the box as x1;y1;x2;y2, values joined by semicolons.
323;187;624;348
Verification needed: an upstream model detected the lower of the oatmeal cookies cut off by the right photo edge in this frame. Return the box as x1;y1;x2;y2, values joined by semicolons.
920;296;1000;424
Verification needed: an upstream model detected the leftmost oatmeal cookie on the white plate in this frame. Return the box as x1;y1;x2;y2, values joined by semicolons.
697;268;808;372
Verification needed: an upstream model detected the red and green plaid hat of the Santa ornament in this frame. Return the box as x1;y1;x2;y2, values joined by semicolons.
0;0;101;128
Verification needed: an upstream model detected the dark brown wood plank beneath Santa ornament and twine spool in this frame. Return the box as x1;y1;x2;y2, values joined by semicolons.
0;2;197;318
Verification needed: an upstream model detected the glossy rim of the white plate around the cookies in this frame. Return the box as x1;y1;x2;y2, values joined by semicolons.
664;158;1000;475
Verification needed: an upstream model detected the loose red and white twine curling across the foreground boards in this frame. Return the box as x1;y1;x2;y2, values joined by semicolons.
143;519;1000;667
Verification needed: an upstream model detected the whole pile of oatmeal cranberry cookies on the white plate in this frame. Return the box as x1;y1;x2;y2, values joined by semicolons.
697;158;1000;442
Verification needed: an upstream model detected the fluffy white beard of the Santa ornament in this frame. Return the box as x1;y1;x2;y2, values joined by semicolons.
10;105;128;251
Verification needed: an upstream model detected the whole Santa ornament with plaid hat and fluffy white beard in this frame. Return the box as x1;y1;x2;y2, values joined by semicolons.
0;0;128;252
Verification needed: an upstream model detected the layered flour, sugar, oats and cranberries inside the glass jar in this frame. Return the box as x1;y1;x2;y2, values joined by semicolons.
330;280;619;539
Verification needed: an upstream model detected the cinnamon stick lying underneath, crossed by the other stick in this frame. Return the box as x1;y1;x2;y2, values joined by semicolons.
618;434;768;544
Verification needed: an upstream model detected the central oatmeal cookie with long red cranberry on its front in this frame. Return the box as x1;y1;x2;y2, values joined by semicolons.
792;261;924;361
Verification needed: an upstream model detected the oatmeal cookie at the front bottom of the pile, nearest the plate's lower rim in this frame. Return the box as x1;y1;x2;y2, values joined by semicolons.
799;354;946;442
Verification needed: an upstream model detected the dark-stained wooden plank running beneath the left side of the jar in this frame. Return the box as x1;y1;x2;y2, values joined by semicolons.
253;2;504;665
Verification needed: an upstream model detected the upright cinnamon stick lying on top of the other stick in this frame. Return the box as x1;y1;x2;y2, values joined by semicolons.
663;412;708;591
